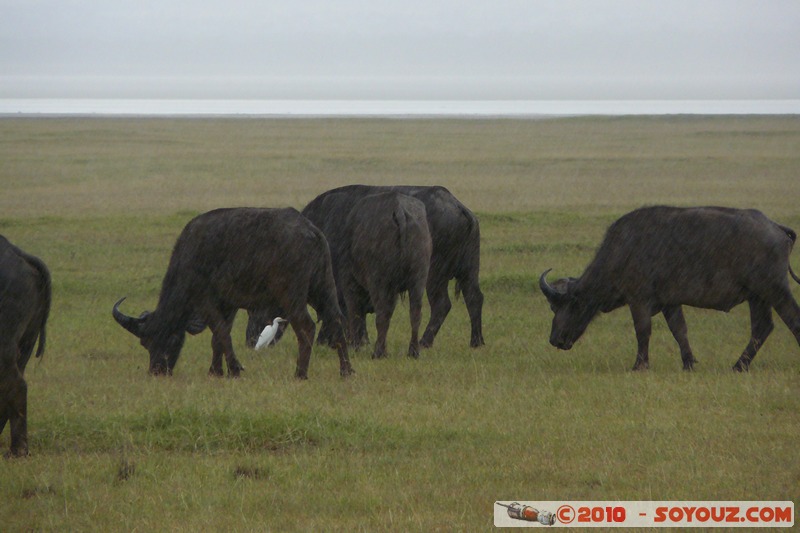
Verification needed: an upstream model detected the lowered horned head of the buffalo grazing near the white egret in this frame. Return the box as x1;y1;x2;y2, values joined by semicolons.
111;298;206;375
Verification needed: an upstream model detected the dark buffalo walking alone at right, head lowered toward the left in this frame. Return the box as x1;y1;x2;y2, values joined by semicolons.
539;207;800;371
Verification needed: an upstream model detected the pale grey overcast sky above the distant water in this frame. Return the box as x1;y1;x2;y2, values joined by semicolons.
0;0;800;100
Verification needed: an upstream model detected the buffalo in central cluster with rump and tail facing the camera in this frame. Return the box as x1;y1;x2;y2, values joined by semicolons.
339;191;432;358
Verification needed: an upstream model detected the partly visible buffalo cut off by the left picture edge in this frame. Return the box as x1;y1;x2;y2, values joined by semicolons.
0;236;51;456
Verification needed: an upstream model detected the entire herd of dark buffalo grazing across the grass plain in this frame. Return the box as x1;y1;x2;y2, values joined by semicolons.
0;185;800;456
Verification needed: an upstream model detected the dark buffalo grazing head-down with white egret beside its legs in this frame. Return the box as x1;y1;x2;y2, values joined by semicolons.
113;208;353;379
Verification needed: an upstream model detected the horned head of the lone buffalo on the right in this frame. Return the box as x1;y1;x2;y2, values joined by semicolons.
539;269;599;350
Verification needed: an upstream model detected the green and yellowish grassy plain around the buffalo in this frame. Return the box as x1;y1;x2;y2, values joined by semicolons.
0;117;800;531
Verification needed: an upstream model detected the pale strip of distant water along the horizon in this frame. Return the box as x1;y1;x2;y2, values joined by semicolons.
0;99;800;117
